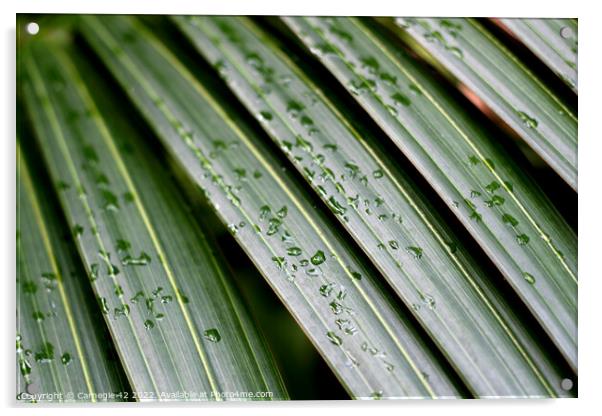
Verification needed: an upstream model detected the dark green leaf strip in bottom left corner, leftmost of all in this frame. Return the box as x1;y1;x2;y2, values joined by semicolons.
17;144;129;402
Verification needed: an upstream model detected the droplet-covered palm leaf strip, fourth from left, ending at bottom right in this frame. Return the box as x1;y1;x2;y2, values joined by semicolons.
174;16;565;397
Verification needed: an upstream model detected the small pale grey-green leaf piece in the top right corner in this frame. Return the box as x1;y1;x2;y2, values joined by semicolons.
500;19;577;92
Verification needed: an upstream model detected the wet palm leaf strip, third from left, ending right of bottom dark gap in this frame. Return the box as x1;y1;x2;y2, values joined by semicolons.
82;17;459;398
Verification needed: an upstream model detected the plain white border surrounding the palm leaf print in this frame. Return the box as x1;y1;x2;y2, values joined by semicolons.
0;0;602;416
